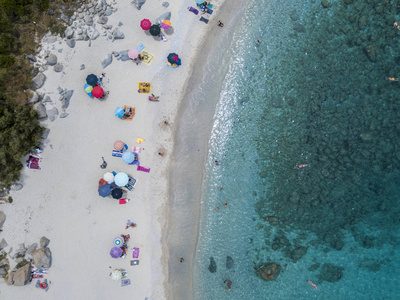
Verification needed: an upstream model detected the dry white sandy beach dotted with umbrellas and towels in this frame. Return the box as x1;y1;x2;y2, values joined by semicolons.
0;0;222;299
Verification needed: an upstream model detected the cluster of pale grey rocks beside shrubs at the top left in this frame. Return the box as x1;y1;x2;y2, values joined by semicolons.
64;0;125;48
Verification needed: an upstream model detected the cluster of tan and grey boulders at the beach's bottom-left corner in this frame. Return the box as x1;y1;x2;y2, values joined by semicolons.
0;237;52;286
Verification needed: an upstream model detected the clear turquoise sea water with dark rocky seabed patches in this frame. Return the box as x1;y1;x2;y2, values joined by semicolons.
194;0;400;299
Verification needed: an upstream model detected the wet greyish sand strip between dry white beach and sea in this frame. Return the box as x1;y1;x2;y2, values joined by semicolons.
163;1;247;299
